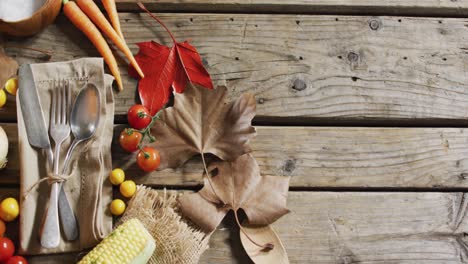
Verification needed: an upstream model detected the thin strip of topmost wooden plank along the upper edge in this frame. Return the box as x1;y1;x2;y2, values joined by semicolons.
113;0;468;16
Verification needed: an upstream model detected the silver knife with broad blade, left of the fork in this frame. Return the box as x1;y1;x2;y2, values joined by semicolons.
18;64;78;244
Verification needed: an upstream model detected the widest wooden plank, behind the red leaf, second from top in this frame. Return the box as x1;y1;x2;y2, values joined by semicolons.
0;13;468;126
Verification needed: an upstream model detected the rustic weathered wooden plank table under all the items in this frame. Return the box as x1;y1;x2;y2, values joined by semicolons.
0;0;468;263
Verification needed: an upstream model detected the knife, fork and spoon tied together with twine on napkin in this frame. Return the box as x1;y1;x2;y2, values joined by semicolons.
18;64;100;248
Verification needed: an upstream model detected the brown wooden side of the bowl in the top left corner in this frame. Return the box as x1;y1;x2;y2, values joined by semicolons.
0;0;62;36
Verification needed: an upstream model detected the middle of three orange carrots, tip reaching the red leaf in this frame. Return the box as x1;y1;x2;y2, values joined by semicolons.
76;0;145;78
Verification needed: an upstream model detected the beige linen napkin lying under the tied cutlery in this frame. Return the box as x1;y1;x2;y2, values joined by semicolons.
17;58;114;255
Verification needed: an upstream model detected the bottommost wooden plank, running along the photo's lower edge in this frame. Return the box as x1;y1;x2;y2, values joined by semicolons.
13;192;468;264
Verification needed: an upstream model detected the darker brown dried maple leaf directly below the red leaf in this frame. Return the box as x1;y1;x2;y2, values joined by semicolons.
151;85;256;169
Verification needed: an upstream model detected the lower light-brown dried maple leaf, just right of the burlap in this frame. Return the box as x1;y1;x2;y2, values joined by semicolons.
179;154;289;232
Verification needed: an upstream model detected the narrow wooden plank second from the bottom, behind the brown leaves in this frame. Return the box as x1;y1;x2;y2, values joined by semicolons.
0;124;468;188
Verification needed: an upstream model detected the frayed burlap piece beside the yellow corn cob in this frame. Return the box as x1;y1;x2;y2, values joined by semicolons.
119;186;210;264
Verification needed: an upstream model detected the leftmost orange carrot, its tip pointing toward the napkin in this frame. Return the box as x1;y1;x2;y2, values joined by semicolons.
63;0;123;90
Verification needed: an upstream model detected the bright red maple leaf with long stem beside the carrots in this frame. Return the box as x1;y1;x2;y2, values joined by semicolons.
129;3;213;115
